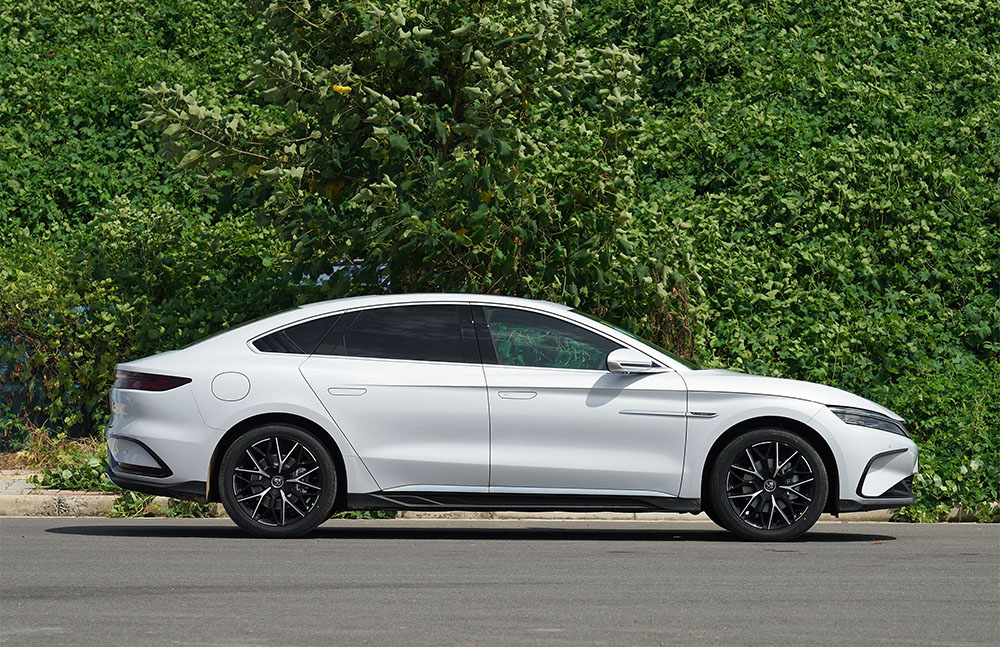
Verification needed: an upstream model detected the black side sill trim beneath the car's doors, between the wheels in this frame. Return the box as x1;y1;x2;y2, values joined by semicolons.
347;492;701;513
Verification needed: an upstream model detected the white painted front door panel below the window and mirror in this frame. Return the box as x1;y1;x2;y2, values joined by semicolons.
484;366;686;495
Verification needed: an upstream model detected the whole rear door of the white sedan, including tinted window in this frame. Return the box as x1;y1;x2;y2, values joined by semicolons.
300;303;489;491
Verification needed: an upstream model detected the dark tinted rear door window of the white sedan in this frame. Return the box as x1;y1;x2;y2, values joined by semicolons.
316;304;479;362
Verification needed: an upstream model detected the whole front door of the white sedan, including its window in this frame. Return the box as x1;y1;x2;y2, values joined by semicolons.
475;305;687;496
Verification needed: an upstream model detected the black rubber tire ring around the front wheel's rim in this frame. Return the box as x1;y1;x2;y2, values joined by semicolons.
709;427;829;541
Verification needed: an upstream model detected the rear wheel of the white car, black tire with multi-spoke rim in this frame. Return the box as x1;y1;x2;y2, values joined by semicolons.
218;424;337;538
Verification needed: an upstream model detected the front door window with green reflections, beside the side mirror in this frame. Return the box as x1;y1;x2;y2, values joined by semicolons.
484;306;622;370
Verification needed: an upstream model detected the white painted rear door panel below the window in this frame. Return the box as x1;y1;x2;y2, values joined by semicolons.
301;356;490;489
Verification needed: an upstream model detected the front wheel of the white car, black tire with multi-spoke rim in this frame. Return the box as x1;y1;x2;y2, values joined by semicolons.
709;428;829;541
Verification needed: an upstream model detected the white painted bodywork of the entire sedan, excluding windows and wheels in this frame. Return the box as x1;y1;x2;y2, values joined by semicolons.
107;294;916;516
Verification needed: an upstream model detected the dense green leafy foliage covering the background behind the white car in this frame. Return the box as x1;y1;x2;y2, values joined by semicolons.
0;0;1000;520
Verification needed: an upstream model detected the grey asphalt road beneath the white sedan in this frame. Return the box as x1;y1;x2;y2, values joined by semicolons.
0;518;1000;647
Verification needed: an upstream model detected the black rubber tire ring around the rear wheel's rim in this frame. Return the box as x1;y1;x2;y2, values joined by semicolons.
217;424;339;538
